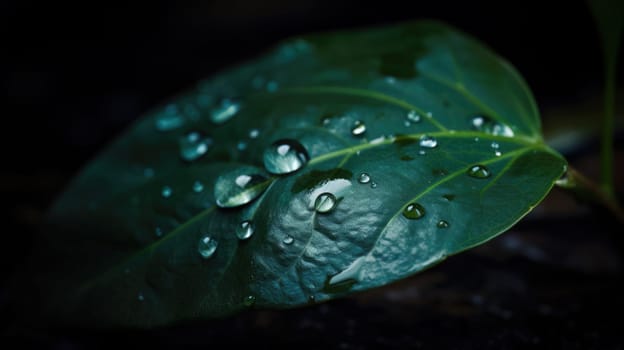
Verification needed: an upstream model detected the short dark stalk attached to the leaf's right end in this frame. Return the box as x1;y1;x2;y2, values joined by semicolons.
556;167;624;224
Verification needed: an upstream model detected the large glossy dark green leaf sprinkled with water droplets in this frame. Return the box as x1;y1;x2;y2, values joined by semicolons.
23;21;566;327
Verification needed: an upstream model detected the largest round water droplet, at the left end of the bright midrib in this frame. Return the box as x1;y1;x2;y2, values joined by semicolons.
264;139;310;174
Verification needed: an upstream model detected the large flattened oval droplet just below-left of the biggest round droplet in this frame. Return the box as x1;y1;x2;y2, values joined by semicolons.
214;166;271;208
